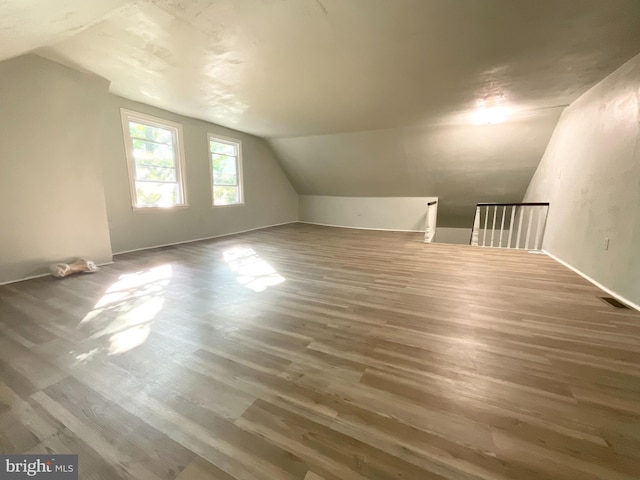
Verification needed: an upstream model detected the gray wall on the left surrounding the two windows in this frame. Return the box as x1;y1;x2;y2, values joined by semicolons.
0;55;298;283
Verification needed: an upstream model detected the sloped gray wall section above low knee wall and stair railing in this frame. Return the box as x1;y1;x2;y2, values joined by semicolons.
269;108;561;228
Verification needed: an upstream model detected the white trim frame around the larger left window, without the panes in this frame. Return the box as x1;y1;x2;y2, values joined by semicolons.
120;108;189;211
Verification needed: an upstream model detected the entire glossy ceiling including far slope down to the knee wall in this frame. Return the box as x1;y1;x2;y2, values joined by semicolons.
0;0;640;224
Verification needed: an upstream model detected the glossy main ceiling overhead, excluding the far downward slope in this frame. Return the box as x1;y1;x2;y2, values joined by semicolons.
11;0;640;137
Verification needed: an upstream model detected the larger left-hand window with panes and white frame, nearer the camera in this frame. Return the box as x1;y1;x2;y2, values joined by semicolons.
121;109;187;208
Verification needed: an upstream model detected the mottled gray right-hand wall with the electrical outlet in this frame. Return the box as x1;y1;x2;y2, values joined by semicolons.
525;55;640;304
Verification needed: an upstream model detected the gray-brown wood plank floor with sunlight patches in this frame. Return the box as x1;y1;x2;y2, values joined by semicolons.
0;224;640;480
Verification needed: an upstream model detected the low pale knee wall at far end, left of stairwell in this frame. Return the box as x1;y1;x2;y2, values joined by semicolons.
300;195;438;232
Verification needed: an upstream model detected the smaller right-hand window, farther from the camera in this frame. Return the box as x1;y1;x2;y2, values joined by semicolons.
209;134;244;206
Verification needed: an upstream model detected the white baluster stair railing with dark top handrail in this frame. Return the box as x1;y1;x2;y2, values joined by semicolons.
469;203;549;250
